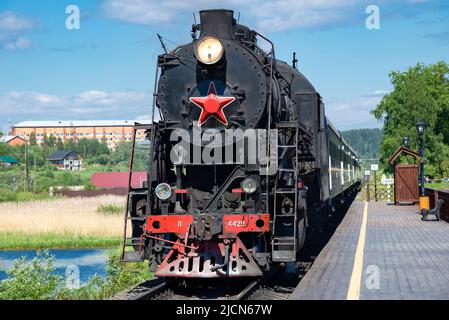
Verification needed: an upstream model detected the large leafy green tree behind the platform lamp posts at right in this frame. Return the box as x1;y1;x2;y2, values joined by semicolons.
372;62;449;176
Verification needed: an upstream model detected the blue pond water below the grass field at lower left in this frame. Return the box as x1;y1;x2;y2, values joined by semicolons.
0;249;109;283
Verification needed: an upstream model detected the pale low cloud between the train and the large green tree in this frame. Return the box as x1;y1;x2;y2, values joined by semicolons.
325;90;389;130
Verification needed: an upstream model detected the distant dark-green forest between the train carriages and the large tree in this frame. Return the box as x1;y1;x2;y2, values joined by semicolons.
341;128;382;159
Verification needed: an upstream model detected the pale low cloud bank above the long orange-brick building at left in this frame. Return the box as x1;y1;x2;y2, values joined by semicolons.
0;90;152;123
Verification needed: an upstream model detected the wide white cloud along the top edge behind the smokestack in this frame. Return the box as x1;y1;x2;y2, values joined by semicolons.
102;0;427;31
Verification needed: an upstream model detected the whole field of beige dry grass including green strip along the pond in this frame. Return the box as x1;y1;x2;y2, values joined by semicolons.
0;196;126;249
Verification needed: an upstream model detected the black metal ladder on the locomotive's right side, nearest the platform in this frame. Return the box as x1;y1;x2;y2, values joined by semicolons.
271;121;299;262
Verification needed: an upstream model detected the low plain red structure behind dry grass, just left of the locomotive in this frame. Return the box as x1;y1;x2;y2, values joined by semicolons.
90;171;147;189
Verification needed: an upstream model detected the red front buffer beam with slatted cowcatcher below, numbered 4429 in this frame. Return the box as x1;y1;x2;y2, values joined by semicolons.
145;214;270;278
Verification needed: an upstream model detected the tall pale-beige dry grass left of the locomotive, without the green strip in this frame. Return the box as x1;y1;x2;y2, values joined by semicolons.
0;195;126;237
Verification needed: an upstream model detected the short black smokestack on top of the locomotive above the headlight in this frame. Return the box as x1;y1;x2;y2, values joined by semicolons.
200;9;236;40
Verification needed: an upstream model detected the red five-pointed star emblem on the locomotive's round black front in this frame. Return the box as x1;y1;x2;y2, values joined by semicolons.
190;82;235;126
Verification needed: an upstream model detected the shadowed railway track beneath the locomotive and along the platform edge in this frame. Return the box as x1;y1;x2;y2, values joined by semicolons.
112;198;349;300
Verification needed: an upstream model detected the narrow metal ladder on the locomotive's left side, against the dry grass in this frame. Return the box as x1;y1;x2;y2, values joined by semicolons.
120;124;154;262
